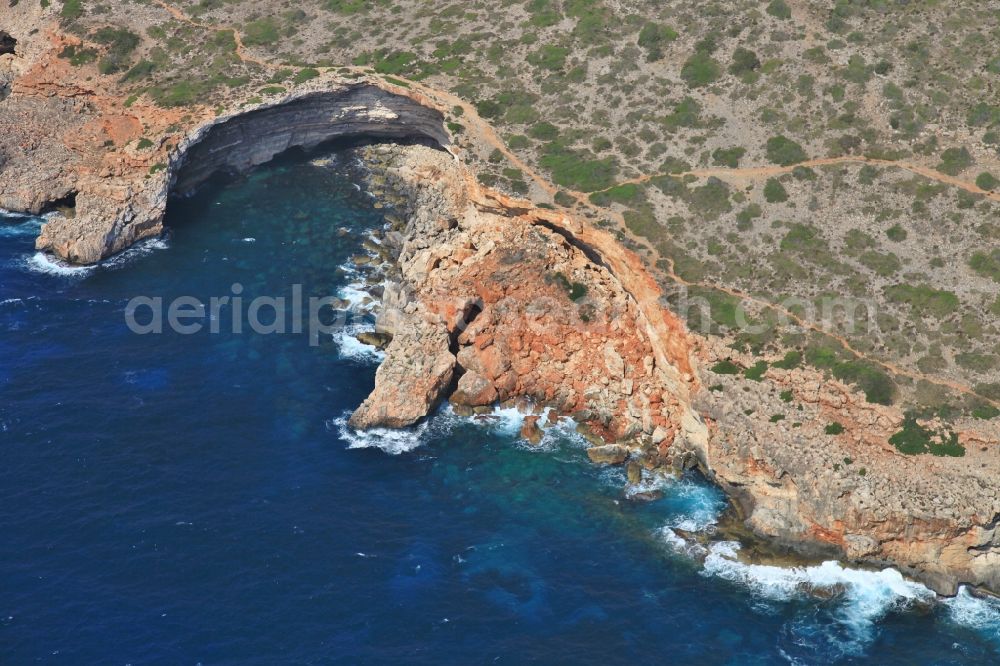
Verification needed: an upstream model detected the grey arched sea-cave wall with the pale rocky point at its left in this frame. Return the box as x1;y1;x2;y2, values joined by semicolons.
24;81;448;264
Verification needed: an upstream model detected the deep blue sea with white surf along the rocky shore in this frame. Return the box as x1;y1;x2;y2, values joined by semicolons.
0;152;1000;665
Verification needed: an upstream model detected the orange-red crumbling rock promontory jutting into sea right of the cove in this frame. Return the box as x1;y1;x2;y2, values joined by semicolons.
351;147;704;446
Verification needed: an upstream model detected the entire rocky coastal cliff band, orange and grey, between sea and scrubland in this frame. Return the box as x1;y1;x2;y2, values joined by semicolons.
0;3;1000;594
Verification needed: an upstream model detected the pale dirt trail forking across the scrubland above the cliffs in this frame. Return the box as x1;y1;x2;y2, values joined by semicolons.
153;0;1000;408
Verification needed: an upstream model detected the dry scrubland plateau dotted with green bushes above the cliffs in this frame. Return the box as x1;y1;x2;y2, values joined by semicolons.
37;0;1000;438
